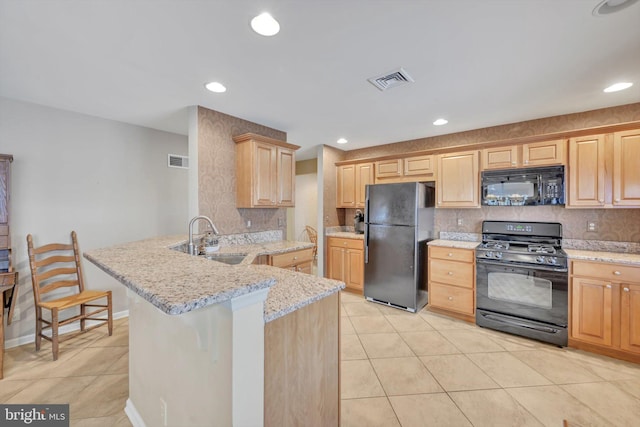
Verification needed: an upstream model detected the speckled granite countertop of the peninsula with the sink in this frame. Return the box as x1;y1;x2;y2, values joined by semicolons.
84;236;345;322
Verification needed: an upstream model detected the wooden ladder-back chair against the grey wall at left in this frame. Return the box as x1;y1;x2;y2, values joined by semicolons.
27;231;113;360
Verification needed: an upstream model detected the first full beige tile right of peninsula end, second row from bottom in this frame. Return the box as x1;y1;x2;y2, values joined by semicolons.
371;357;442;396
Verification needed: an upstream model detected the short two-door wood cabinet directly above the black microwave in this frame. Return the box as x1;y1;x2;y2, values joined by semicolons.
482;139;567;170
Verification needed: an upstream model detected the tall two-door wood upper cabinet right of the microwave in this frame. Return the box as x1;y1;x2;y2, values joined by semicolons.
566;130;640;208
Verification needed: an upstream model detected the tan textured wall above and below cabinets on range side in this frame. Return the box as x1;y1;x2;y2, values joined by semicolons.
325;103;640;242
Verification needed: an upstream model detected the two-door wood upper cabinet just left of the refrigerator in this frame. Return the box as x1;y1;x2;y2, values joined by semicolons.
336;162;373;208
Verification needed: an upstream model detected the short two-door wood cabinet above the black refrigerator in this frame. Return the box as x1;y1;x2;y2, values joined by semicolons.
375;155;435;183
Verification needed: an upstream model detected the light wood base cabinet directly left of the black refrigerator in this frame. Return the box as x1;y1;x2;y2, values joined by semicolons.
327;237;364;293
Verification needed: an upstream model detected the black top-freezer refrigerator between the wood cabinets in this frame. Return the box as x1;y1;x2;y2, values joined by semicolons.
364;182;435;312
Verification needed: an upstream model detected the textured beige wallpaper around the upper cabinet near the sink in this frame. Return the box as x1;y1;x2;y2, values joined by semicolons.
198;107;287;234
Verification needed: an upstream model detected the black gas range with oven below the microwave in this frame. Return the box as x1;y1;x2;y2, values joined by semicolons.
476;221;568;346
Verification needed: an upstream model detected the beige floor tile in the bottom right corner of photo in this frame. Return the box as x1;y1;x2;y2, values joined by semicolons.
561;382;640;426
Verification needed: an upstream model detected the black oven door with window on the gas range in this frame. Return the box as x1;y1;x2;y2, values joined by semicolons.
476;259;568;328
